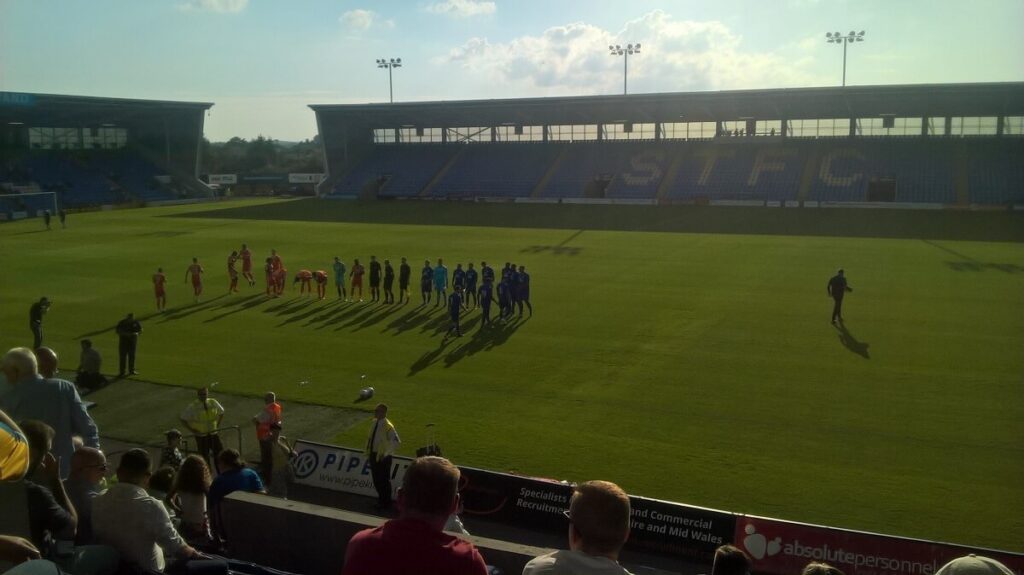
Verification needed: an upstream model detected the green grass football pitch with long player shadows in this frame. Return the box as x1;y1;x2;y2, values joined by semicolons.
0;200;1024;551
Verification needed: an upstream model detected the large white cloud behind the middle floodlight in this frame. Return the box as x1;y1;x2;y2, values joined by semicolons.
441;10;821;95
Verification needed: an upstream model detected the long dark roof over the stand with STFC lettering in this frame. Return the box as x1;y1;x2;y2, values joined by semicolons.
309;82;1024;127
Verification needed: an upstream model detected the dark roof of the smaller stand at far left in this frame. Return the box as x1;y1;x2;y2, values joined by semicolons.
0;92;213;127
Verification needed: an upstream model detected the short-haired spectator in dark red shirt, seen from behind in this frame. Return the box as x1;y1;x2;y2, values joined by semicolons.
341;456;487;575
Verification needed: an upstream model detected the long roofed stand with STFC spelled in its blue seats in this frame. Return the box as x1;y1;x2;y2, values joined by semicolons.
310;83;1024;207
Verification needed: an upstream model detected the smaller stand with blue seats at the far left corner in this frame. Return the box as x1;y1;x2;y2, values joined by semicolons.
0;92;213;214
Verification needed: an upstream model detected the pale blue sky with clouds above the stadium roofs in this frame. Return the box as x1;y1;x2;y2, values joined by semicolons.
0;0;1024;140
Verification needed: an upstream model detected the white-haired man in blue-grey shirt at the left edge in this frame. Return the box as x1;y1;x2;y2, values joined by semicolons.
0;348;99;479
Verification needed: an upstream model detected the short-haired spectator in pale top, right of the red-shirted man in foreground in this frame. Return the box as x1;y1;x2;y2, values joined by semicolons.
522;481;630;575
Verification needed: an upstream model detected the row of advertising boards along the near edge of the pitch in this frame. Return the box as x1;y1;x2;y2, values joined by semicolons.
293;440;1024;575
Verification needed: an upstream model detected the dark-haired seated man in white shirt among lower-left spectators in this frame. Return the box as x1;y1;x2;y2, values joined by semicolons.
92;449;203;571
